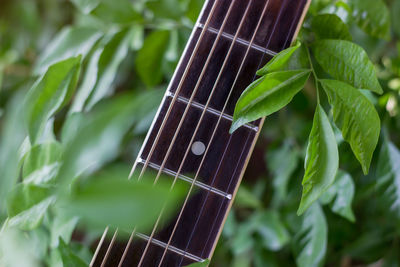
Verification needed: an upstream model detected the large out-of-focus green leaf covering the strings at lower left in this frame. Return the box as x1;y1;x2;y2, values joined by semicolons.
60;172;185;230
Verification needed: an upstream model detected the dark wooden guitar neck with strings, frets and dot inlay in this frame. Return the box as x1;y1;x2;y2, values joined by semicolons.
90;0;310;266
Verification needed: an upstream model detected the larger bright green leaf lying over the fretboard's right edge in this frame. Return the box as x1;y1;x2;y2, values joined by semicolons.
230;70;310;133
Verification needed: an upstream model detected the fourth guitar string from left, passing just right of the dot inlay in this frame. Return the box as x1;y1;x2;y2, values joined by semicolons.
159;0;269;266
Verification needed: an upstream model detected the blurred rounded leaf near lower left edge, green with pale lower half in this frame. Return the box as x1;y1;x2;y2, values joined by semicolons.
7;184;55;230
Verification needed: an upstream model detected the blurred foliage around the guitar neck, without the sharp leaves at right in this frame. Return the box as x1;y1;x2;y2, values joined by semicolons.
0;0;400;266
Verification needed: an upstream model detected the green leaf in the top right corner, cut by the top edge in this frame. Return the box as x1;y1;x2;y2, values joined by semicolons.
350;0;390;40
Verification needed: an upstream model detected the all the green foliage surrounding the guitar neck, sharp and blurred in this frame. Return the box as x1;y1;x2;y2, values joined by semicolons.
0;0;400;267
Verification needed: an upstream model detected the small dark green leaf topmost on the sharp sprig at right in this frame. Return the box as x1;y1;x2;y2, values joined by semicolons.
311;14;353;41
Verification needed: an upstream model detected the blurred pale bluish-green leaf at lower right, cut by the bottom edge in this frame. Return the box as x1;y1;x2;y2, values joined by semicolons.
293;203;328;267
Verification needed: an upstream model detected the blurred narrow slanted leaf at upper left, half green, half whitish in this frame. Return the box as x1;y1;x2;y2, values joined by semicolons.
83;31;132;111
